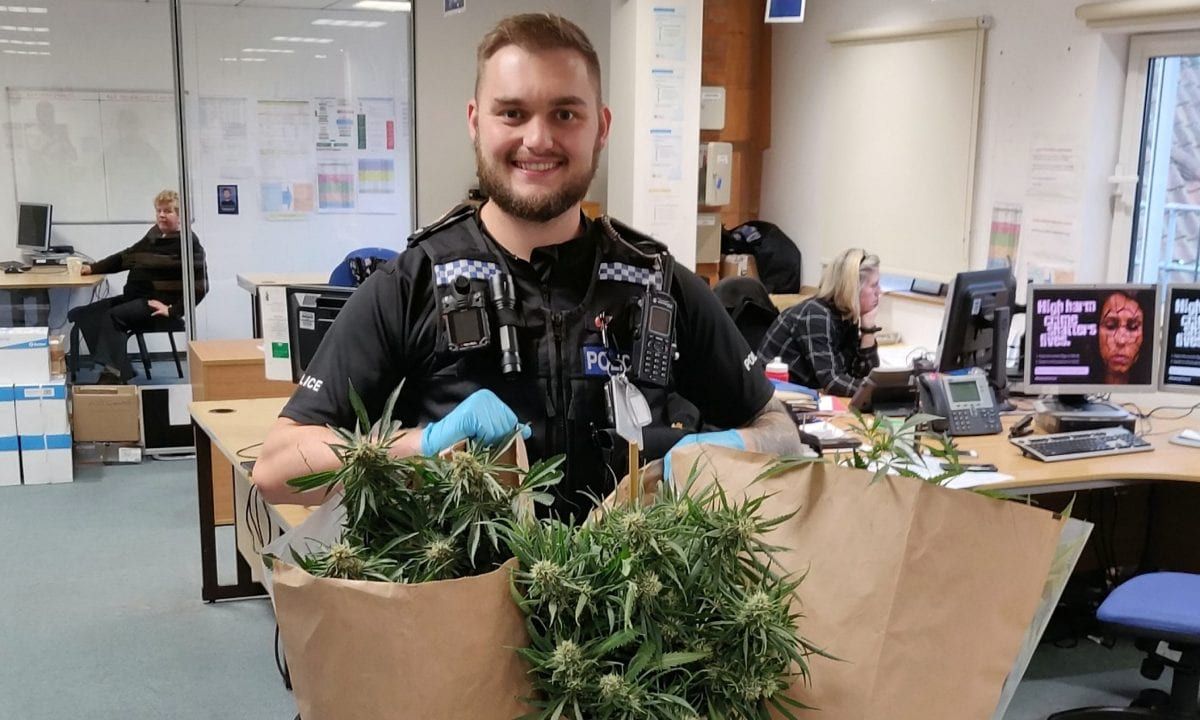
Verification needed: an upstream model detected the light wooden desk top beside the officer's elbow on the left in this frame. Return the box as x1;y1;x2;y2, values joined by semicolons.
188;397;312;528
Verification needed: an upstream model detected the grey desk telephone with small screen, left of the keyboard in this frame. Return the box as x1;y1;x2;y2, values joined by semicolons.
918;368;1002;436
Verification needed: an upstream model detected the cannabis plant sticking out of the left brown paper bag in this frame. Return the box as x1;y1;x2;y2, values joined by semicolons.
278;386;562;582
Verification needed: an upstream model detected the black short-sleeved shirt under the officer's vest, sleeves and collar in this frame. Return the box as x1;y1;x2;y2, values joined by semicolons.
281;216;773;446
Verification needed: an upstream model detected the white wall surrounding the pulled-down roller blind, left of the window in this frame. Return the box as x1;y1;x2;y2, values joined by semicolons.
761;0;1128;289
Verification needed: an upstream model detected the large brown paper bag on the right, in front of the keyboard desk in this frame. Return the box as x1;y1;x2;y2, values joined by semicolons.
672;445;1060;720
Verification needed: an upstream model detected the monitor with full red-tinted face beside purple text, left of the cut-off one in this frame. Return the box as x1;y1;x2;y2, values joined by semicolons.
1025;284;1158;407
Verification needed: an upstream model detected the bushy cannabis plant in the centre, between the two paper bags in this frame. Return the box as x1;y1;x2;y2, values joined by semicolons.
506;462;821;720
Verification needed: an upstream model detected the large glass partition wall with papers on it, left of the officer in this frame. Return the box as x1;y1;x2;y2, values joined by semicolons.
0;0;414;382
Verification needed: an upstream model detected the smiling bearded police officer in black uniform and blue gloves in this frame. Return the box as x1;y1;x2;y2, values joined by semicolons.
254;14;800;515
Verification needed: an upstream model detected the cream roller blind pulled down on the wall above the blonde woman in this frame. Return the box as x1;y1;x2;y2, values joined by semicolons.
821;28;984;280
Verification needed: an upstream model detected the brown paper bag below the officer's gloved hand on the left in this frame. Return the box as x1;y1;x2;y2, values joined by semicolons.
275;560;532;720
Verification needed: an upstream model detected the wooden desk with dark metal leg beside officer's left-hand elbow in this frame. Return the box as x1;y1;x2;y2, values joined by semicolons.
188;397;311;602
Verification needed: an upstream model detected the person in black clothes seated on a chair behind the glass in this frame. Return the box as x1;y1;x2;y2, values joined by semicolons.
67;190;208;384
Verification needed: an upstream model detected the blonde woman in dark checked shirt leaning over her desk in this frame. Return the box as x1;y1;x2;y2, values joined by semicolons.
758;247;880;397
